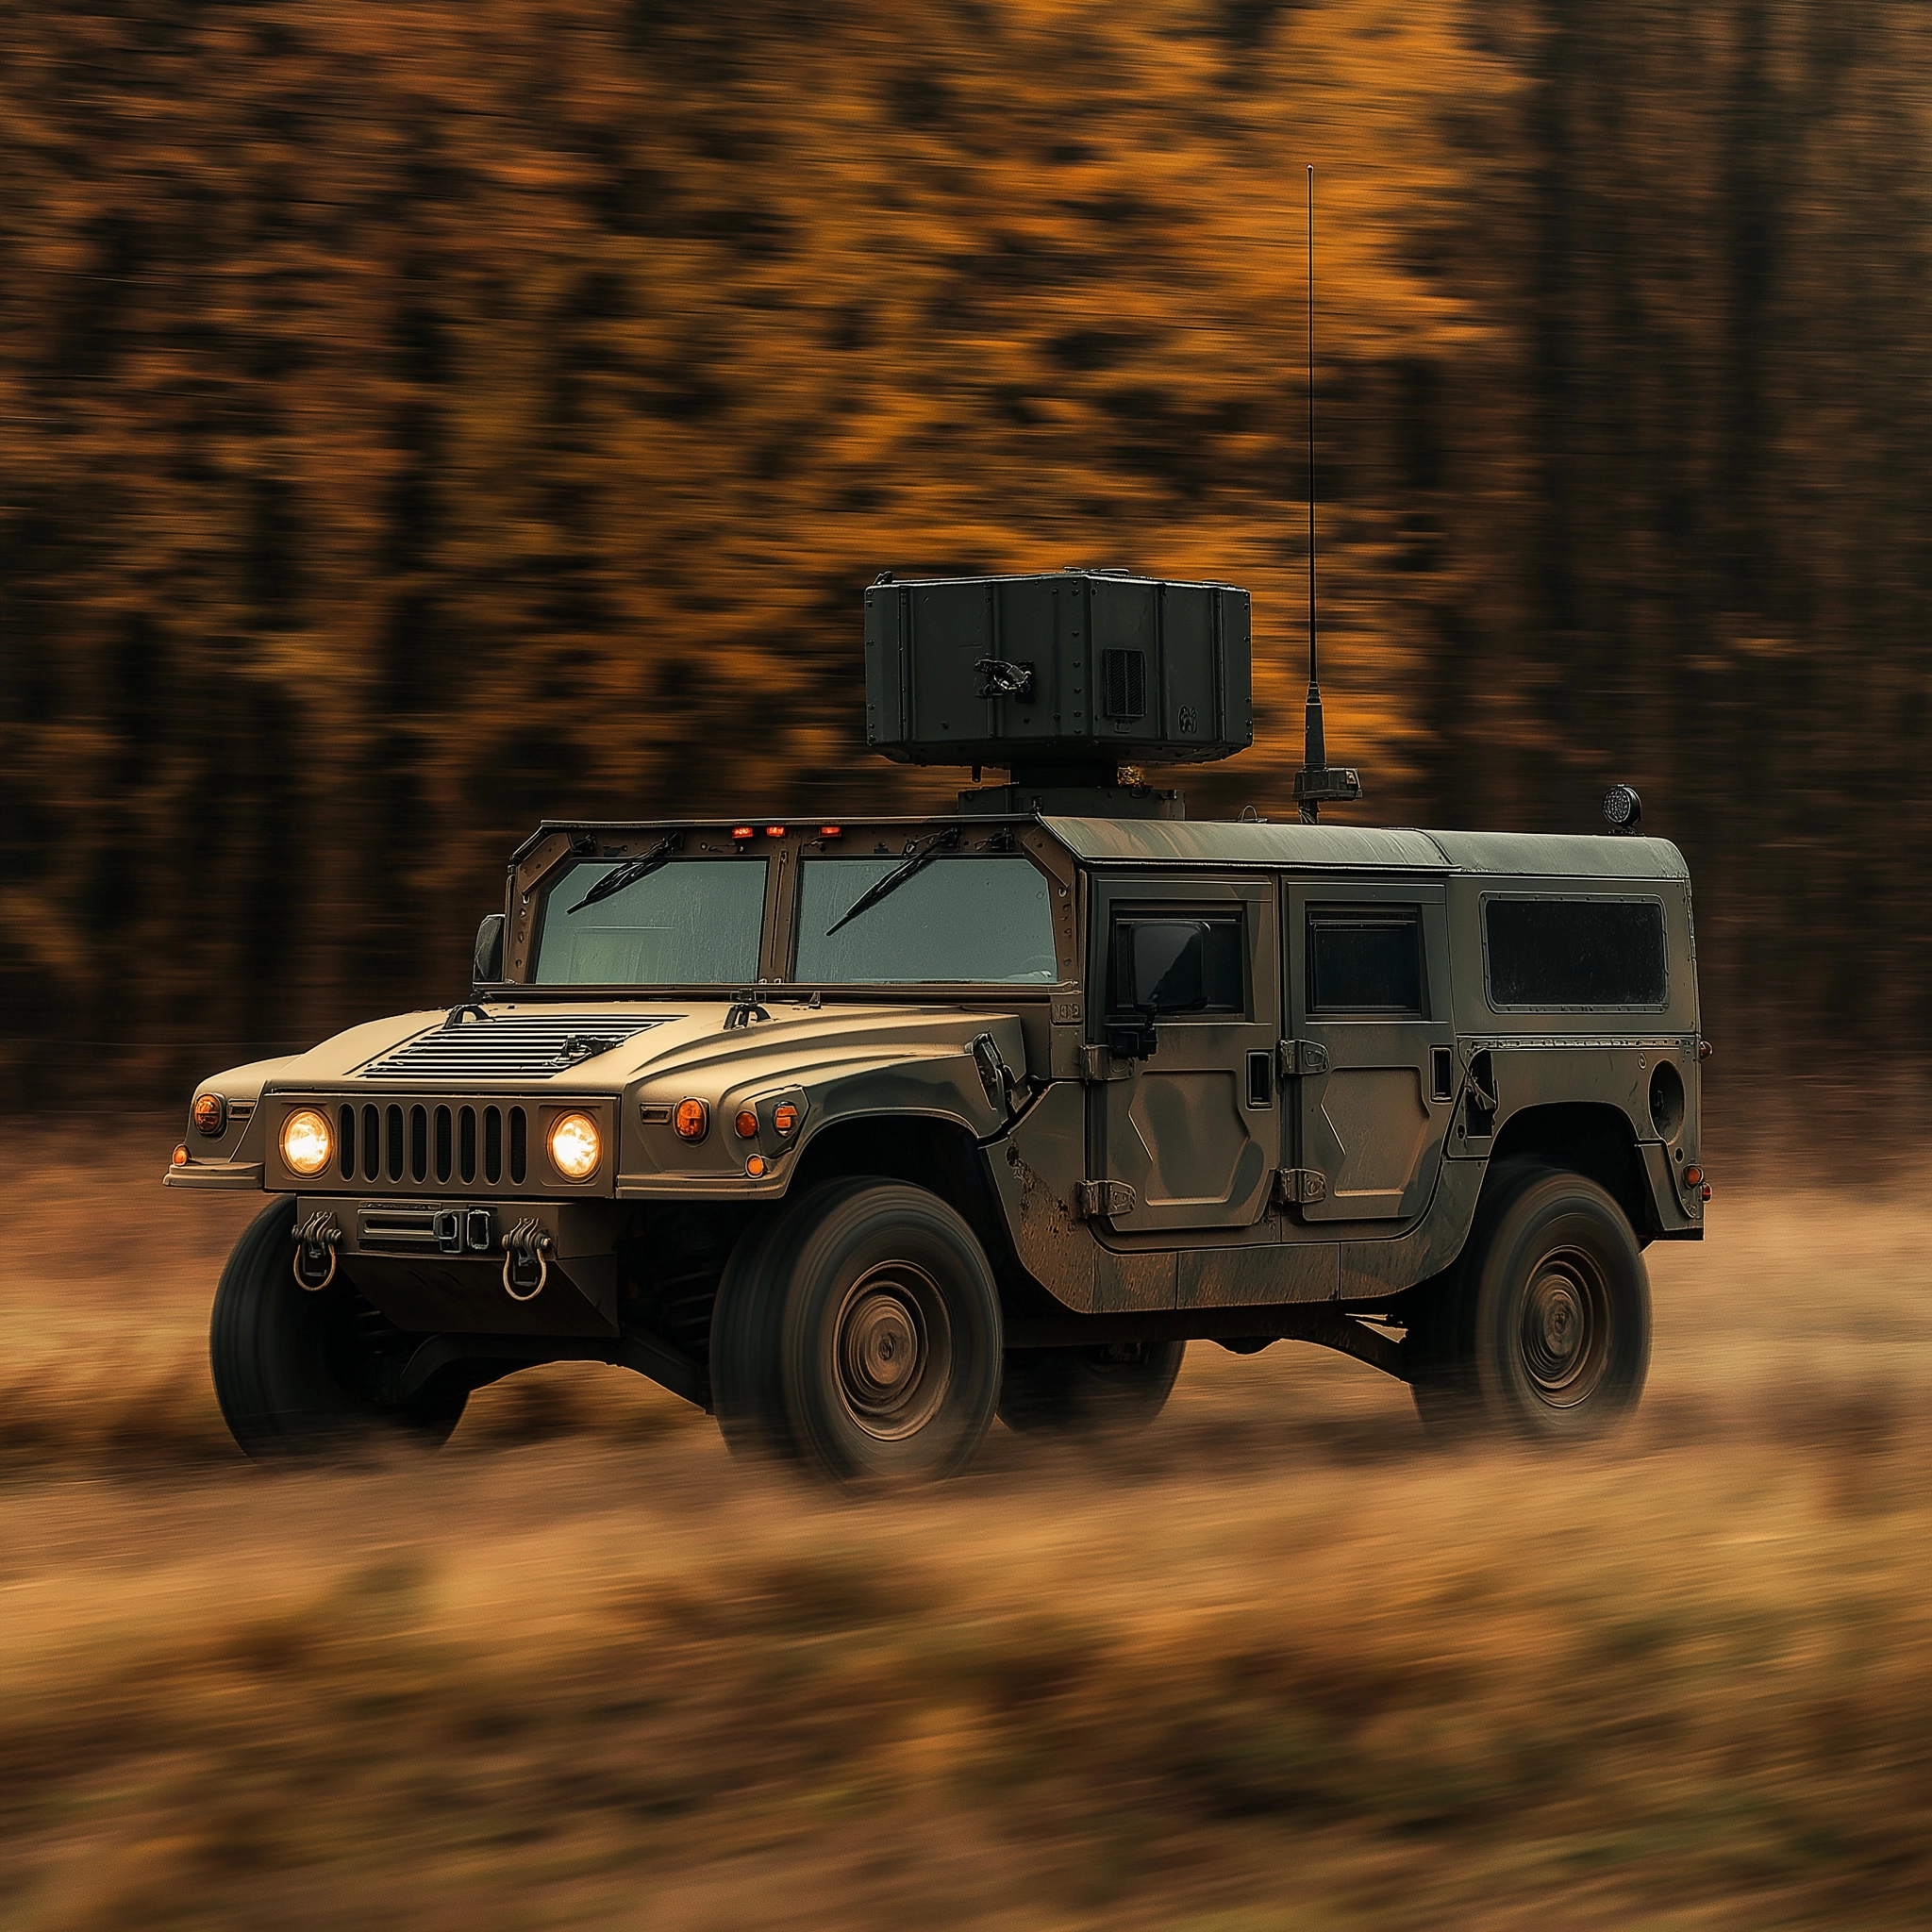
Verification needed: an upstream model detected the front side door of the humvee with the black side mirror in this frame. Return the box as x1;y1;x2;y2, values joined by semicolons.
1088;879;1281;1233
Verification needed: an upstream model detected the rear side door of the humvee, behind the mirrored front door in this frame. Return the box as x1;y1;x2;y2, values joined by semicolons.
1283;881;1455;1223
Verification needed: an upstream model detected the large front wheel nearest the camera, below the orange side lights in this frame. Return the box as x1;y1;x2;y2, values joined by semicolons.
711;1178;1001;1488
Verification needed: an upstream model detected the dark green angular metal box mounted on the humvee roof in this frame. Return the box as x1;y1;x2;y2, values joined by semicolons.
866;570;1254;776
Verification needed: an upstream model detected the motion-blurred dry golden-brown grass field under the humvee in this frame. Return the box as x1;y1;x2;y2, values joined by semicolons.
0;1126;1932;1932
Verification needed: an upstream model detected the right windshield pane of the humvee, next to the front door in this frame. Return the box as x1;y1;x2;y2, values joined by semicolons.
794;854;1058;985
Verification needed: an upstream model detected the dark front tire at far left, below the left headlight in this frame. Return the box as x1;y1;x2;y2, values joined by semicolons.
208;1194;470;1462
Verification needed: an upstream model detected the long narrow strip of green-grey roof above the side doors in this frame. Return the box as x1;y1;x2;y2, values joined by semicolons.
1041;817;1690;879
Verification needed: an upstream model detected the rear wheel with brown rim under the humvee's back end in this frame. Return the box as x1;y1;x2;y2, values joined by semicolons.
1412;1163;1650;1441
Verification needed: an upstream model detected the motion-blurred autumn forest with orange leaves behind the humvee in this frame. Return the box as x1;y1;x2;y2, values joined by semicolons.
0;0;1932;1101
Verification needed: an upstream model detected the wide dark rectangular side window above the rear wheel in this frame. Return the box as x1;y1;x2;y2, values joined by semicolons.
1482;898;1669;1007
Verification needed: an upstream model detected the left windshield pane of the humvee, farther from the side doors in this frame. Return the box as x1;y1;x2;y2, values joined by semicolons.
535;858;765;985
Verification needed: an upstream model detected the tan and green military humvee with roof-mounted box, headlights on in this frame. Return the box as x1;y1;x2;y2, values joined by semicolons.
166;570;1707;1484
